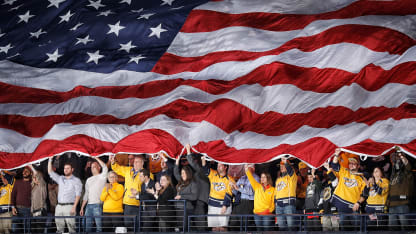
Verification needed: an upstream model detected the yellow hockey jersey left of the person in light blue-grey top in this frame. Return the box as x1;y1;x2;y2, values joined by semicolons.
208;169;235;207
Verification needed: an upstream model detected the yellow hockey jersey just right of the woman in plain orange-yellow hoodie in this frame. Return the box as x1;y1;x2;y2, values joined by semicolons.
275;166;298;206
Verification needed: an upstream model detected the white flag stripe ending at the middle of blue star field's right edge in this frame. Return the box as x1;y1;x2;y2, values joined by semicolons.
168;15;416;57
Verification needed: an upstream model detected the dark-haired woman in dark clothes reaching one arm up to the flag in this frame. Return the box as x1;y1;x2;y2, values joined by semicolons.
173;156;198;232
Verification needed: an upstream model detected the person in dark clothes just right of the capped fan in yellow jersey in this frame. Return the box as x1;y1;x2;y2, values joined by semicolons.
304;168;322;231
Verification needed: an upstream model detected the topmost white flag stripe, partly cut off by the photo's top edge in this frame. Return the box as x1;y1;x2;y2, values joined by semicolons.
195;0;357;14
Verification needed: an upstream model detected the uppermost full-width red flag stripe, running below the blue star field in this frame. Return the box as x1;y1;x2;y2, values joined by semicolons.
0;62;416;103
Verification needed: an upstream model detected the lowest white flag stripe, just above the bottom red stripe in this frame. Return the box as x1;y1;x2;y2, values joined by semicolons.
0;115;416;153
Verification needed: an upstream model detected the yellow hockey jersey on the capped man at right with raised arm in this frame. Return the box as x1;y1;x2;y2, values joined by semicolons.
332;164;366;211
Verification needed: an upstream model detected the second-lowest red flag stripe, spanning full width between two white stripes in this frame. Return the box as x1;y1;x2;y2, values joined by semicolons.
0;99;416;137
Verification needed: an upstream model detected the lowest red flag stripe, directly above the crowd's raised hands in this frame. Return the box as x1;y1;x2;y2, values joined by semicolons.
0;132;416;169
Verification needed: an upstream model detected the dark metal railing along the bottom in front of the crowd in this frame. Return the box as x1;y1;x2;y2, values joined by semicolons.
0;200;416;233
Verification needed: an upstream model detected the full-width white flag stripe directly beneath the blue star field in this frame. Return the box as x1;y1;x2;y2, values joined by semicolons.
0;43;416;92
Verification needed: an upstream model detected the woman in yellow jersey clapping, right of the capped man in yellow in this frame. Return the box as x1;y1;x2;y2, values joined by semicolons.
364;167;390;230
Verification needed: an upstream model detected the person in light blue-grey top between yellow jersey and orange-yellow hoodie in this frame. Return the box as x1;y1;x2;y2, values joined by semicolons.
230;164;256;231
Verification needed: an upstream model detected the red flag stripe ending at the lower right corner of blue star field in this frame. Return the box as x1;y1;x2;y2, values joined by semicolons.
152;25;416;74
